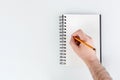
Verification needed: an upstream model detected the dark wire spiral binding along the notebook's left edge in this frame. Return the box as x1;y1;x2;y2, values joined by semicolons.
59;15;66;65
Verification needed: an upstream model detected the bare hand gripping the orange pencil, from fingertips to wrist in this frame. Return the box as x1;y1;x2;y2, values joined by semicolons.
70;29;97;62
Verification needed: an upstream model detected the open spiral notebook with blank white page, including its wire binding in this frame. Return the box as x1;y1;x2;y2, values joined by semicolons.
59;14;101;68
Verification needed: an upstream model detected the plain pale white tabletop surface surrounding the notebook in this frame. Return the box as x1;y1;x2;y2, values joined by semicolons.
0;0;120;80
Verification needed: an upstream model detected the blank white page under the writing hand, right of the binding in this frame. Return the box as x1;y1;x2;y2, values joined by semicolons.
64;14;100;68
